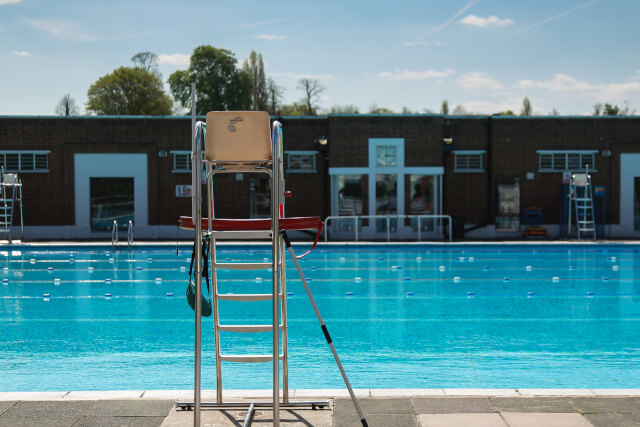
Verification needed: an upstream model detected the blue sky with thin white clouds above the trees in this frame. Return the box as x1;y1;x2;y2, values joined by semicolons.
0;0;640;115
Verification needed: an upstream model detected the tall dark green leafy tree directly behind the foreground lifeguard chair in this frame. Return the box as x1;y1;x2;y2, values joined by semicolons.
169;45;252;114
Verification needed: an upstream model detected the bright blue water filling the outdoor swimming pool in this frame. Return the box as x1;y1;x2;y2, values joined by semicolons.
0;244;640;391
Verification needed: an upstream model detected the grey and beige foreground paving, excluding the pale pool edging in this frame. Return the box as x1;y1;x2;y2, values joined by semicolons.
0;395;640;427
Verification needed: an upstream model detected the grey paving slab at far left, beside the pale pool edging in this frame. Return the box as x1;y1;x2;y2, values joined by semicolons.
2;400;99;419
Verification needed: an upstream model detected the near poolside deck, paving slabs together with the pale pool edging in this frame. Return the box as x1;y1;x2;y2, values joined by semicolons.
0;389;640;427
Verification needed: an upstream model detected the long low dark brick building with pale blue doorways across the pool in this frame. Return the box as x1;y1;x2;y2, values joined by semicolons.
0;115;640;239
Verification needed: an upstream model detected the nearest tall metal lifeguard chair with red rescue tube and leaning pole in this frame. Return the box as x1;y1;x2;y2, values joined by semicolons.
176;105;367;426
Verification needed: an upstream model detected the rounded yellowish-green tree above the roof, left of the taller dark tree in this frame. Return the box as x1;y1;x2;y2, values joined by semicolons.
87;67;172;116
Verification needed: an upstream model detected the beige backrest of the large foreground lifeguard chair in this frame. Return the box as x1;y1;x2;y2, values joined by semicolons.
205;111;272;163
